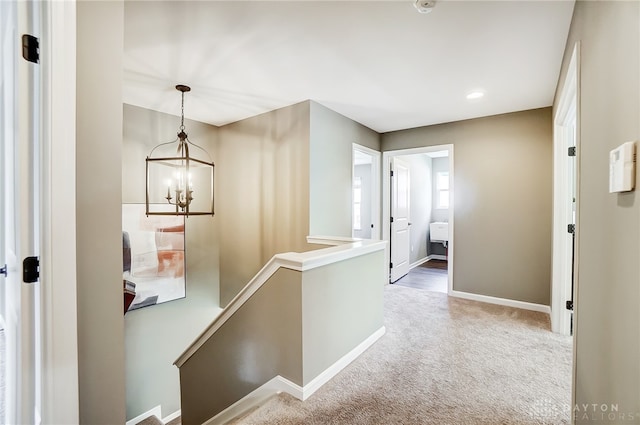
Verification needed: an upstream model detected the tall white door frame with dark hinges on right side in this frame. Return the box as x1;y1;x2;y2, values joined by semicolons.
551;42;580;335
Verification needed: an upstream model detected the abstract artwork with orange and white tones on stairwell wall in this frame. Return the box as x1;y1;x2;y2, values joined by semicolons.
122;204;186;313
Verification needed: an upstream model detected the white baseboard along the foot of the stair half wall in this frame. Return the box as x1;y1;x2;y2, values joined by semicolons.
205;326;386;425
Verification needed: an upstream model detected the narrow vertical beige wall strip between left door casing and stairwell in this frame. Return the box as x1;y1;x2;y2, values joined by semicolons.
75;1;125;424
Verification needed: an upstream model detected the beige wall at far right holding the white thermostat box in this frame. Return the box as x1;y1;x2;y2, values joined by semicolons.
558;1;640;418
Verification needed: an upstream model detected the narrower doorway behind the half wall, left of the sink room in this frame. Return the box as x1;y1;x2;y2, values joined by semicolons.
351;143;380;239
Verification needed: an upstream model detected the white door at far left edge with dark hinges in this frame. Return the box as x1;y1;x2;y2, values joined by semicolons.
0;1;40;424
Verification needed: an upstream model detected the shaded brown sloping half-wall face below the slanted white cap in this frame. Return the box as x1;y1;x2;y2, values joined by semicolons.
180;269;302;425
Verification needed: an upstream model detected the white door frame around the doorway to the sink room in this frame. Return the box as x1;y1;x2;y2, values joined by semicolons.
382;144;455;295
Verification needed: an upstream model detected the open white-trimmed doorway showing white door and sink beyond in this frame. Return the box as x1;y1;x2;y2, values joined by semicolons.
383;145;454;293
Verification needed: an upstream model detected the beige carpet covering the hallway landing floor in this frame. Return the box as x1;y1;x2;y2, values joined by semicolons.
233;285;572;425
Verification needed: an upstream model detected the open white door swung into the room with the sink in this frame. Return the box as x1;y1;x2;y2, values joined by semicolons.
391;157;411;282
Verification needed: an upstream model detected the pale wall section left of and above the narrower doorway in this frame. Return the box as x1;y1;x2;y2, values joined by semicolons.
309;101;380;237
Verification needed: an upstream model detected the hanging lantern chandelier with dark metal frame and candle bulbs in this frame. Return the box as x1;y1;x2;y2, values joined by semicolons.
146;85;215;216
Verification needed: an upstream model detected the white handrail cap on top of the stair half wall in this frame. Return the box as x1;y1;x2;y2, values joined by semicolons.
173;236;387;367
